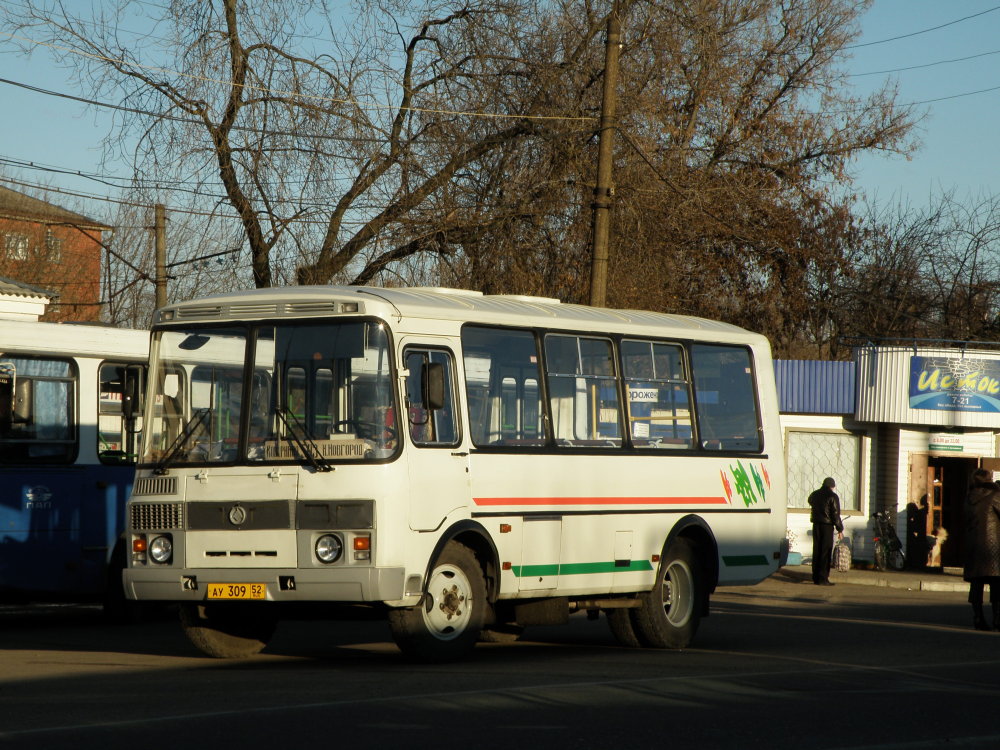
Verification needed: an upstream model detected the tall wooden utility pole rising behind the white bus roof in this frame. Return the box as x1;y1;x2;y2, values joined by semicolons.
590;0;621;307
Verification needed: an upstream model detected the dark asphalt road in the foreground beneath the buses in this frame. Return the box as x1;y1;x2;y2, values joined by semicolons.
0;578;1000;750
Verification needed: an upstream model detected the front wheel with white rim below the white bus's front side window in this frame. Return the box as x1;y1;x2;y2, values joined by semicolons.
389;541;487;662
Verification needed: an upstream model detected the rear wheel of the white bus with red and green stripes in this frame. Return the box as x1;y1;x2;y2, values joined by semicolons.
633;538;705;649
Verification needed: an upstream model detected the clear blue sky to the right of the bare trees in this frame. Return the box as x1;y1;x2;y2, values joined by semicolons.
850;0;1000;206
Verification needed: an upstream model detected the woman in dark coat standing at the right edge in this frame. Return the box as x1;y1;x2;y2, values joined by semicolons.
964;469;1000;630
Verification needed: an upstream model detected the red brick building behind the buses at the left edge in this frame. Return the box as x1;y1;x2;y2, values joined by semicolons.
0;187;110;321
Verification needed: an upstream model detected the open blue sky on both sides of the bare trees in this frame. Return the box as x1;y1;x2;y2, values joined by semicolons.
0;0;1000;220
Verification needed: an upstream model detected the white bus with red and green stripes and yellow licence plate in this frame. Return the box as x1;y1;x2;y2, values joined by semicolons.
125;286;785;660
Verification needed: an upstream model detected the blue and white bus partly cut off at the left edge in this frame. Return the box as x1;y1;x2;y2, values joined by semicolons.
0;320;149;608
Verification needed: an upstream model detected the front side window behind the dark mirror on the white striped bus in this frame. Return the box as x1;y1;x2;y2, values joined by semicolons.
405;349;459;446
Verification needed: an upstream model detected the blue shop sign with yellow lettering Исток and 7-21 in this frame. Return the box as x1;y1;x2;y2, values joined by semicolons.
910;357;1000;412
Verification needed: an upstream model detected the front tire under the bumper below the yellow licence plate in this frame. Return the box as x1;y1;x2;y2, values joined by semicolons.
180;602;278;659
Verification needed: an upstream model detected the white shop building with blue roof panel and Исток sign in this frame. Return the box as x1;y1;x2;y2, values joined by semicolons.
775;343;1000;567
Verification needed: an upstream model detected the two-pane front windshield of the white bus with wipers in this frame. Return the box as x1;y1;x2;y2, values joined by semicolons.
143;321;398;470
